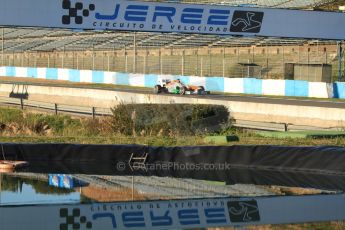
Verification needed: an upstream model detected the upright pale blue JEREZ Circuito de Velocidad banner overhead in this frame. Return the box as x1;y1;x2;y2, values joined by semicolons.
0;0;345;40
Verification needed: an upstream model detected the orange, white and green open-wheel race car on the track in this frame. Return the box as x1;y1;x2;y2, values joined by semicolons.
153;79;210;95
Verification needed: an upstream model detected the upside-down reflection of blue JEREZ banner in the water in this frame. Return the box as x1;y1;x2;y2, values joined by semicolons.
0;194;345;230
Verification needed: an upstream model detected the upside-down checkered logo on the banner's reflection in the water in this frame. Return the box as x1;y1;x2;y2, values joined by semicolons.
60;208;92;230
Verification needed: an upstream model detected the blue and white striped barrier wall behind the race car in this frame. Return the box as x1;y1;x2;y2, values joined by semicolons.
0;67;345;98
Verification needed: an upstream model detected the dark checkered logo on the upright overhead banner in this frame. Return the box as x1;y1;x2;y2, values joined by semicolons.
62;0;95;25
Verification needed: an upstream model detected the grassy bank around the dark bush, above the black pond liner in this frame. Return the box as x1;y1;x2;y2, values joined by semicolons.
0;107;345;146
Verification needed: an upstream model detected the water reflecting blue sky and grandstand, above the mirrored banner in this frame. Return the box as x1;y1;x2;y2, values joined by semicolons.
0;172;331;205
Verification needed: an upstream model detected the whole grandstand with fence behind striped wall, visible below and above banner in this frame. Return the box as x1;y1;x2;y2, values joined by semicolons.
1;0;342;78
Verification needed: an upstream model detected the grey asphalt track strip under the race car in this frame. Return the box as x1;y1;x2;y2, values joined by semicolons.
0;80;345;109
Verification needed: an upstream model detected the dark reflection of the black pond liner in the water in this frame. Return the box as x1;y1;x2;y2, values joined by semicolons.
14;159;345;191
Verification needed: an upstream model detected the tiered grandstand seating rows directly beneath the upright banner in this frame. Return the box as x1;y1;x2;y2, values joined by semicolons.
3;28;314;53
